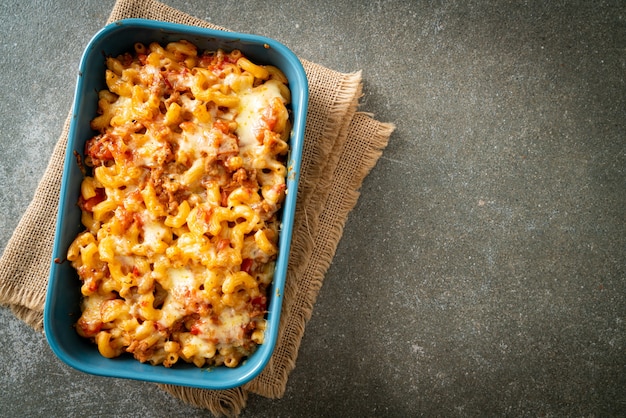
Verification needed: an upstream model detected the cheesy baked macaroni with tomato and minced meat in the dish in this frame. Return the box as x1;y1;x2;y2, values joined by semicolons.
67;40;291;367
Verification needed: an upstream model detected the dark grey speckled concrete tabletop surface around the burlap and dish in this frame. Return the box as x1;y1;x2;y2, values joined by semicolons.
0;0;626;417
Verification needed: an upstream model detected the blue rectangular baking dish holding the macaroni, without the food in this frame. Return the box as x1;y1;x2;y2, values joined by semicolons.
44;19;308;389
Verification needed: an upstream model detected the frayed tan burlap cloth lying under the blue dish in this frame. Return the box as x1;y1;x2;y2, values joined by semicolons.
0;0;394;415
